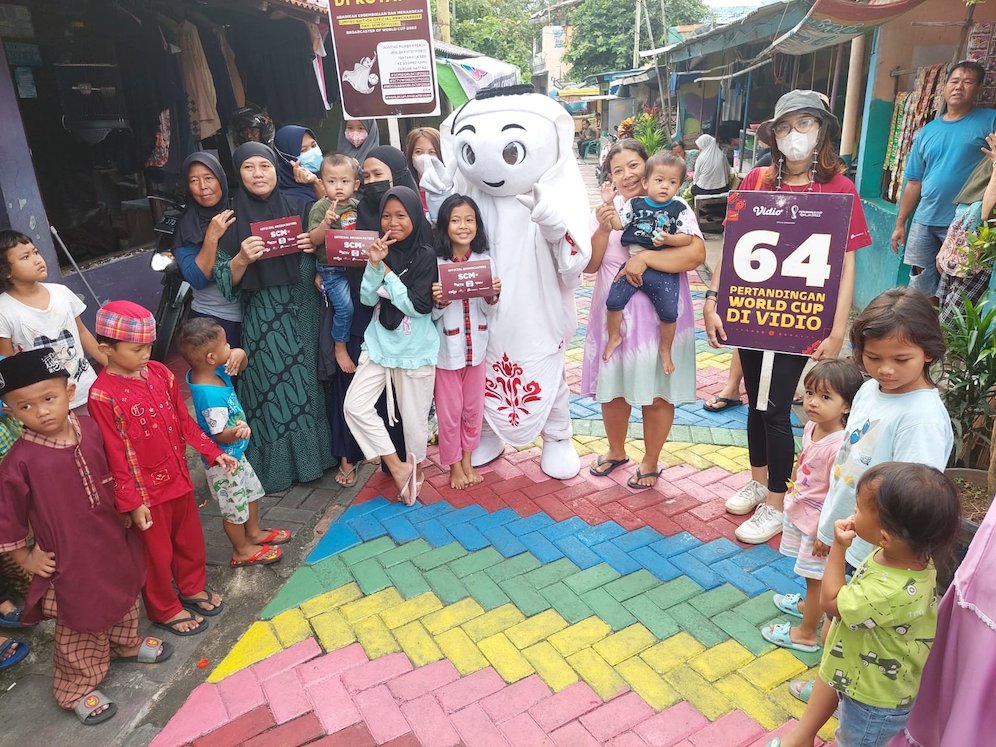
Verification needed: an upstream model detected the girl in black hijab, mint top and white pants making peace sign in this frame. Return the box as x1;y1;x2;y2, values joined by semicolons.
345;187;439;505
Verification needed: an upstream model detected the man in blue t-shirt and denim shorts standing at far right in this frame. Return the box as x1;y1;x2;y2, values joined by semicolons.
892;60;996;296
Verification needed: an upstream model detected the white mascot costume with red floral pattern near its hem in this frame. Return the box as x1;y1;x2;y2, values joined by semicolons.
421;86;591;480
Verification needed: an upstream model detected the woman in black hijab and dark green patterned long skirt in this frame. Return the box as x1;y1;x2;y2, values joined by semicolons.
214;143;332;500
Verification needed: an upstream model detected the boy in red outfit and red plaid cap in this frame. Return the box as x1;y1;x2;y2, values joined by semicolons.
89;301;238;636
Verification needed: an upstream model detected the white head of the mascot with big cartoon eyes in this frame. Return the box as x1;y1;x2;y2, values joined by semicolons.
445;86;574;196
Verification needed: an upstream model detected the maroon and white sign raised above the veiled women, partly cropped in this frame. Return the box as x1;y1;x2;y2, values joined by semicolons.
329;0;439;119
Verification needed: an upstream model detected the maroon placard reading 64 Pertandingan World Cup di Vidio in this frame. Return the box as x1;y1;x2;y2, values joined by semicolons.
716;192;854;355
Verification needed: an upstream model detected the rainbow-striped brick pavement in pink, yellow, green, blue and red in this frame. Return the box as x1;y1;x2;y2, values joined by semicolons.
152;165;834;747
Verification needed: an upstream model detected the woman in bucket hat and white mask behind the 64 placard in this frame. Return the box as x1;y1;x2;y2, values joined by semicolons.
702;91;871;554
